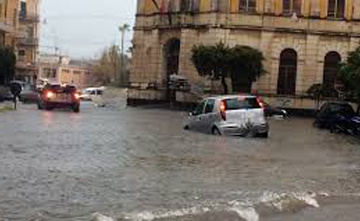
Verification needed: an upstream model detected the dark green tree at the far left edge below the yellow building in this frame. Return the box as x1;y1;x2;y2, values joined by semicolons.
0;47;16;85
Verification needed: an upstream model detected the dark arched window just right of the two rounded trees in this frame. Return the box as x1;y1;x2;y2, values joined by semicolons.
277;49;297;95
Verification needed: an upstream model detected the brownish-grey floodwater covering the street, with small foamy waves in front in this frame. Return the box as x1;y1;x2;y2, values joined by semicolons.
0;103;360;221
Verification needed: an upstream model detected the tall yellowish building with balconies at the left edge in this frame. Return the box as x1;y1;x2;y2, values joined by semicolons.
0;0;40;84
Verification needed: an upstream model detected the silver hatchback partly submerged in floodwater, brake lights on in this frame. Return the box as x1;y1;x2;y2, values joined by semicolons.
184;95;269;137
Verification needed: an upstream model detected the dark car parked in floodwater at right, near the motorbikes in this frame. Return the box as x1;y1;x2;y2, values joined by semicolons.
314;102;355;129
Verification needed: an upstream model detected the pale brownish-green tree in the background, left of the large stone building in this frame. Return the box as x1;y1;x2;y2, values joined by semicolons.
93;45;129;86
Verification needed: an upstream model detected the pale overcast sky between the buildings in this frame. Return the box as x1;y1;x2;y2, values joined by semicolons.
40;0;136;58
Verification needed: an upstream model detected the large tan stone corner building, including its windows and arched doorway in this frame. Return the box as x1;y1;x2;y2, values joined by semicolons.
129;0;360;107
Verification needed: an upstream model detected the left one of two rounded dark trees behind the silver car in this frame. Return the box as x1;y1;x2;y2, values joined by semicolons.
191;42;230;94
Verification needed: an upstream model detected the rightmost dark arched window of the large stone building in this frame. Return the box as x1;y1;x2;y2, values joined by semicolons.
323;51;341;97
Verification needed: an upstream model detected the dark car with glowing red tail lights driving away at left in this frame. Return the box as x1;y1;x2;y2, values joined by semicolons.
38;84;80;112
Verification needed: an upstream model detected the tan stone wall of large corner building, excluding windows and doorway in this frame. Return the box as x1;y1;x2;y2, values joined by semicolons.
130;0;360;107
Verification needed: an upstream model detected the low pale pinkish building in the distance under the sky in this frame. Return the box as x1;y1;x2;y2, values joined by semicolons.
38;55;93;89
